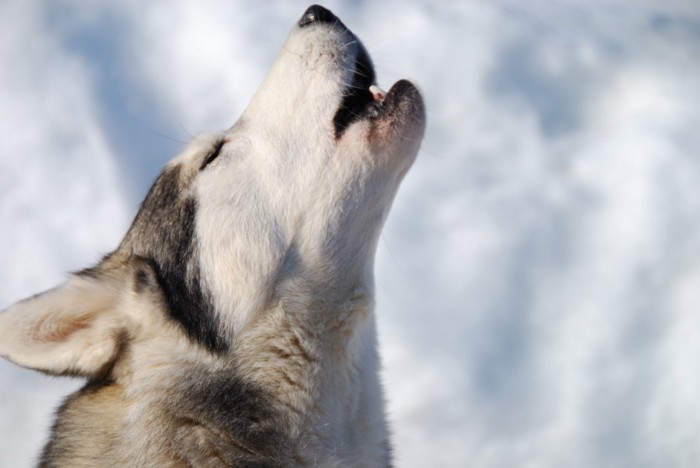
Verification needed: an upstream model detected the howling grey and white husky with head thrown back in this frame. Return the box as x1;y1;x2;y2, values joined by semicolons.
0;5;425;467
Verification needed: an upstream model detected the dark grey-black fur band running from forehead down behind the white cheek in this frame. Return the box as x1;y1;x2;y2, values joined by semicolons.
122;166;228;351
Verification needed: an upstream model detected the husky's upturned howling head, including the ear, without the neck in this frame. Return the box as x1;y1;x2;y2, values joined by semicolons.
0;6;425;375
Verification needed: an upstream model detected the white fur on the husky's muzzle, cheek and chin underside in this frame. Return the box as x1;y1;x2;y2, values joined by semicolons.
196;18;415;335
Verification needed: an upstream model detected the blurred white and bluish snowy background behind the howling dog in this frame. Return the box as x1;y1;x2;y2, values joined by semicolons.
0;0;700;468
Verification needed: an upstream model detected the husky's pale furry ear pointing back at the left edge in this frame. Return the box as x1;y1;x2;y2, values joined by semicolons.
0;273;129;377
